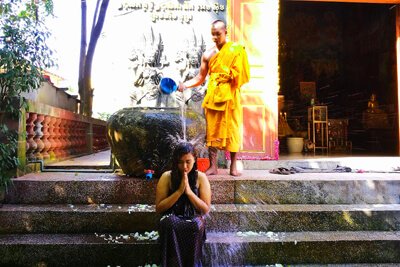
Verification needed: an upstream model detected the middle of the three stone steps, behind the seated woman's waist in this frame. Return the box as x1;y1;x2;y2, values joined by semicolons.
0;204;400;234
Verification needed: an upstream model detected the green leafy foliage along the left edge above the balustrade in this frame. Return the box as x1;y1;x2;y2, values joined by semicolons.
0;0;55;193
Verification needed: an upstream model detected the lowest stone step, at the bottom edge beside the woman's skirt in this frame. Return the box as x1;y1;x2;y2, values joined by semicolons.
0;232;400;266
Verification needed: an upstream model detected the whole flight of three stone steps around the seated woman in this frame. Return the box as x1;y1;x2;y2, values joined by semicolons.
0;170;400;266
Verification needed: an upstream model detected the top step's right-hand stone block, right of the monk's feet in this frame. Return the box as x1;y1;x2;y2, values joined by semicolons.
234;171;400;204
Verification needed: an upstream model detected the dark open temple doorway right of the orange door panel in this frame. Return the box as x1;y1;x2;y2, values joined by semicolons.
279;1;398;156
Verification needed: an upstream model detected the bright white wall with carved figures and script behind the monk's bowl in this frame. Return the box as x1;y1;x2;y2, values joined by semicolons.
93;0;228;113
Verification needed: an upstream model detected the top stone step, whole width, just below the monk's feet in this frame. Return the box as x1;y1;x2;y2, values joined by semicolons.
6;170;400;204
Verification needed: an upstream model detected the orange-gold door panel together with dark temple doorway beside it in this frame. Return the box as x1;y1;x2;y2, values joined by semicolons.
208;0;399;160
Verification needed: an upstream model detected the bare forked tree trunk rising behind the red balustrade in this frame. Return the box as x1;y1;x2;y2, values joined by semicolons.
78;0;109;117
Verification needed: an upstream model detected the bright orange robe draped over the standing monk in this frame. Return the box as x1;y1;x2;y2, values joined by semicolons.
202;42;250;152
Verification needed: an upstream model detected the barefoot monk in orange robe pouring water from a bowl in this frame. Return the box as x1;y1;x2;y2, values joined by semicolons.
178;20;250;176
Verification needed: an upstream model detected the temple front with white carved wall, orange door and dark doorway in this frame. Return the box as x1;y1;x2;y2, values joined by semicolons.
110;0;399;160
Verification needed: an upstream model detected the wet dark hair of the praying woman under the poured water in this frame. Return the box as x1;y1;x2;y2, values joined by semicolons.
171;142;197;191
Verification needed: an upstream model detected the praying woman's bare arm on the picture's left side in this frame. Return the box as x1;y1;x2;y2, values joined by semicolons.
156;172;185;214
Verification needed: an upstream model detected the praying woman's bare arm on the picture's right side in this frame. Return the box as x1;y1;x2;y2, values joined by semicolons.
185;172;211;214
